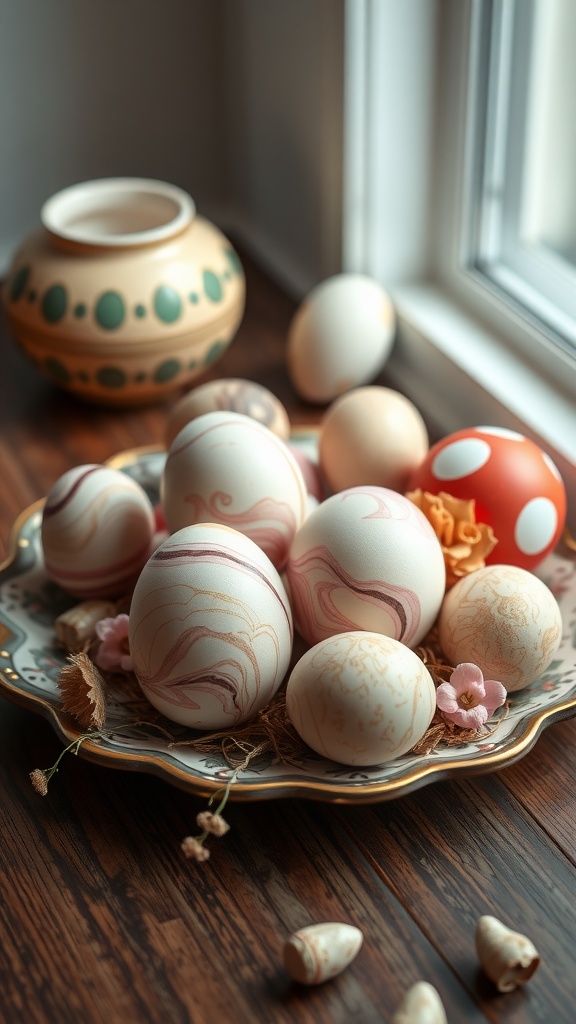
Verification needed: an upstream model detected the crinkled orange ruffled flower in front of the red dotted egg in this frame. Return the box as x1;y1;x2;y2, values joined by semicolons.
406;488;498;587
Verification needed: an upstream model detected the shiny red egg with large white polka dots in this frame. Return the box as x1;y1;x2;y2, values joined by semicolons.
409;427;566;569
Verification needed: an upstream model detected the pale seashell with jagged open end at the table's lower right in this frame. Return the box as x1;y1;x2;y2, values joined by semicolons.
476;914;540;992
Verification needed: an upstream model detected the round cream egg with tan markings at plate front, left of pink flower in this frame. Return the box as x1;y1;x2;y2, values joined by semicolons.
286;632;436;765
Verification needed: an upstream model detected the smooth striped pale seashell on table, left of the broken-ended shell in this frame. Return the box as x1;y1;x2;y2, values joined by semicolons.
284;921;363;985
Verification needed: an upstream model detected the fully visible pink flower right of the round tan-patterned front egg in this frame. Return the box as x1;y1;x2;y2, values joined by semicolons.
436;662;506;729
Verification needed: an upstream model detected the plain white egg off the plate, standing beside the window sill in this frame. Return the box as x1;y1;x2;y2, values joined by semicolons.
287;273;396;402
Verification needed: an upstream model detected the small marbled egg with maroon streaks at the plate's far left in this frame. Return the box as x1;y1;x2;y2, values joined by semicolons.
41;464;155;597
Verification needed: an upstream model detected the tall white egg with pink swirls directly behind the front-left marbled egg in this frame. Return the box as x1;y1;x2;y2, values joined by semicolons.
162;413;307;568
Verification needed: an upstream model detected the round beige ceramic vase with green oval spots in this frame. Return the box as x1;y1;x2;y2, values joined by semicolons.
4;178;245;406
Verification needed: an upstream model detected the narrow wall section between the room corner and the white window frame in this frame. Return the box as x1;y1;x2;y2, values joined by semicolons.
222;0;344;296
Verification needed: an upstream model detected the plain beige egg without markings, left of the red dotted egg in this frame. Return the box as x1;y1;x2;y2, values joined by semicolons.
319;386;428;493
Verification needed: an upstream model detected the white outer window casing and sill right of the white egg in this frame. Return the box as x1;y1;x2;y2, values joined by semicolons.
342;0;576;535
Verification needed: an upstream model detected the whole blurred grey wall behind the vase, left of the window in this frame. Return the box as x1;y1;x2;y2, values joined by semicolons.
0;0;343;291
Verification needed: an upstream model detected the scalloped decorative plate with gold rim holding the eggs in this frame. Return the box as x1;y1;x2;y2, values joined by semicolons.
0;429;576;803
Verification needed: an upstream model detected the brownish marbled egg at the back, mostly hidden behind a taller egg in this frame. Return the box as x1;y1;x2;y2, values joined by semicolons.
166;377;290;447
